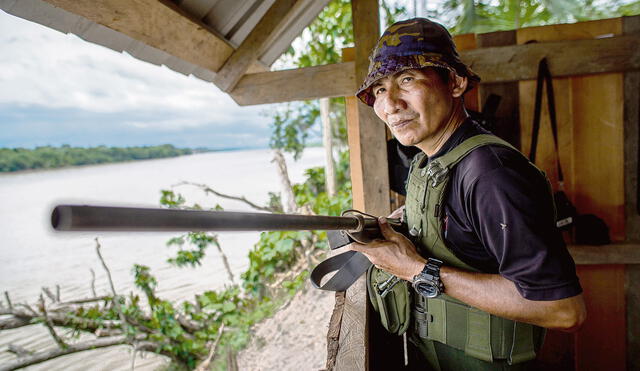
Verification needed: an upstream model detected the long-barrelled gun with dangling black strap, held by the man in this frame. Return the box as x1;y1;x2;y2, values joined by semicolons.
51;205;406;291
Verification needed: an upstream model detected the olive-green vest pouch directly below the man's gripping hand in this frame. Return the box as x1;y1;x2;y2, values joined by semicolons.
367;265;411;335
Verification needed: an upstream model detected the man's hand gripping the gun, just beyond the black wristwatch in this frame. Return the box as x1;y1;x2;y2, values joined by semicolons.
349;217;427;282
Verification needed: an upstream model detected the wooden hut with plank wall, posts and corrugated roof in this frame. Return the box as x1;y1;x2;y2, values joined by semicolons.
0;0;640;370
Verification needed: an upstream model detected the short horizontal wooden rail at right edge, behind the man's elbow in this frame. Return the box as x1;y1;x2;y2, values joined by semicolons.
568;243;640;265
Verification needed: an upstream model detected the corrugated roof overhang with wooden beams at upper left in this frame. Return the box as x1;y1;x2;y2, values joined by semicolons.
0;0;329;101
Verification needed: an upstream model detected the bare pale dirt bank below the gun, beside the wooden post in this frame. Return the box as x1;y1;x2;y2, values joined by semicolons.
238;283;335;371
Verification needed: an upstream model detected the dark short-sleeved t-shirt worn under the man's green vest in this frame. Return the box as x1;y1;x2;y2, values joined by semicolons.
425;120;582;300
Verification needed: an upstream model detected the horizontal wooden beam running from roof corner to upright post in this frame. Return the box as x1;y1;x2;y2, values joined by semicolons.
229;62;357;106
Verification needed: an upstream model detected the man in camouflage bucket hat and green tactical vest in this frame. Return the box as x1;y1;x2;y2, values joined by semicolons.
351;18;586;370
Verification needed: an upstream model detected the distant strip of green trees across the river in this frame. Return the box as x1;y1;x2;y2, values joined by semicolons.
0;144;196;172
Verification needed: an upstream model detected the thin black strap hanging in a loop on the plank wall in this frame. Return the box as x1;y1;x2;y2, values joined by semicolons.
529;58;564;187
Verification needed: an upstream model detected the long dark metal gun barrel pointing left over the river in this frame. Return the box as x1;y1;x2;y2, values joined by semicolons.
51;205;364;232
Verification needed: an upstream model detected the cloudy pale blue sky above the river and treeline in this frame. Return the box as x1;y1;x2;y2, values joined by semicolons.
0;10;272;149
